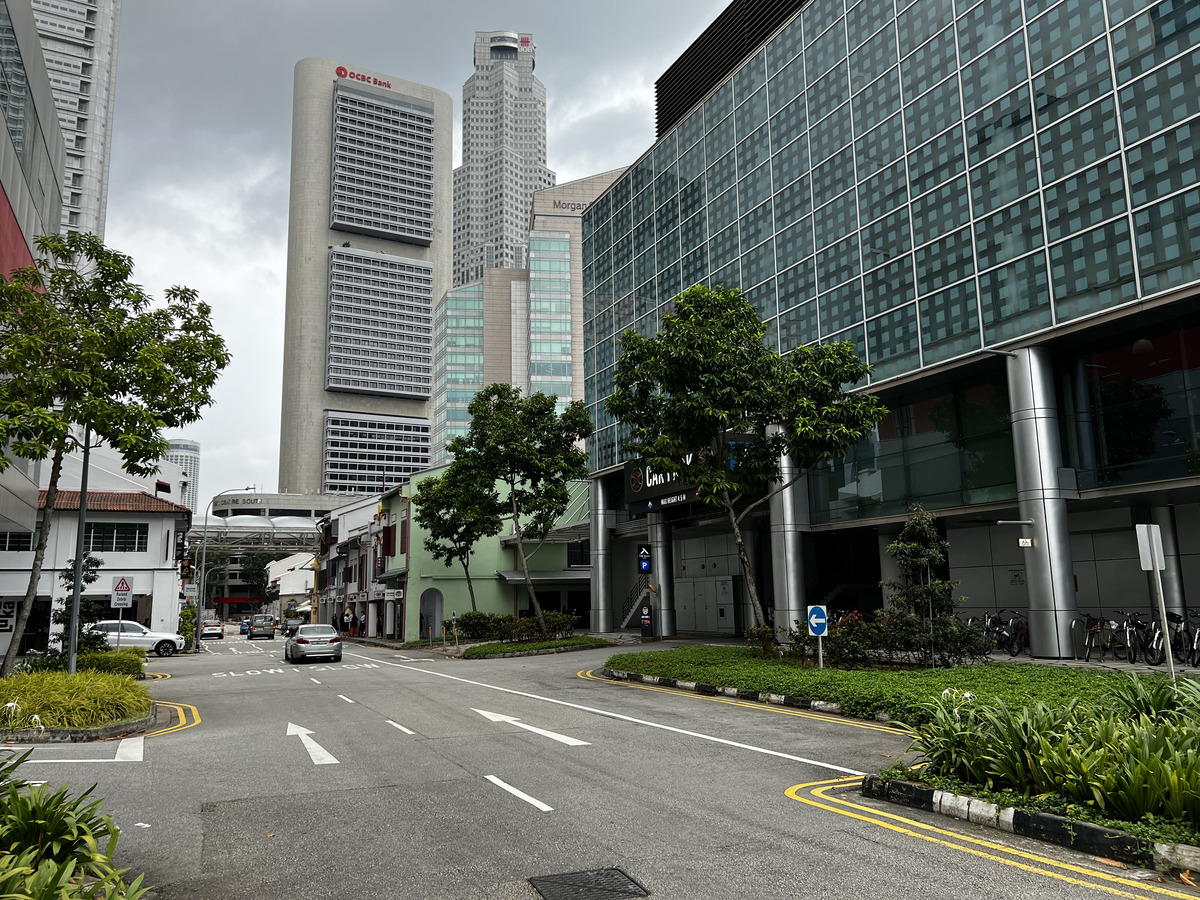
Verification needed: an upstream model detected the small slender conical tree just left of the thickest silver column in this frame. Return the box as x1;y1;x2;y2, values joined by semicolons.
880;503;959;620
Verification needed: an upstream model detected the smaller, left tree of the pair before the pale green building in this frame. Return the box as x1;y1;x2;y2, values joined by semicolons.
413;460;500;612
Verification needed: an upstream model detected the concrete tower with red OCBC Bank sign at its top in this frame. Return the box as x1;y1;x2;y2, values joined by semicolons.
280;59;452;493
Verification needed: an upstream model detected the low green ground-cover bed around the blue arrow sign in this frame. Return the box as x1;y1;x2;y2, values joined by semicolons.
607;646;1137;725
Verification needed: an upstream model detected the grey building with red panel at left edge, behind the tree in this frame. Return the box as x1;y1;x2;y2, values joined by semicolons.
0;0;65;542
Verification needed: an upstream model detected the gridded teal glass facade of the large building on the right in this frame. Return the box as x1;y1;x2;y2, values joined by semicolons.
583;0;1200;470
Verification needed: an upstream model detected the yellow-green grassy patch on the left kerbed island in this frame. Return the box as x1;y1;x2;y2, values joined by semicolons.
0;671;150;731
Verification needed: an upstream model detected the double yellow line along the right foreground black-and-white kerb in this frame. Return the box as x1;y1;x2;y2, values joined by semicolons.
786;778;1196;900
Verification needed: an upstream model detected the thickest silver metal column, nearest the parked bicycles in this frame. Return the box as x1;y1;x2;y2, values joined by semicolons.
1007;347;1075;659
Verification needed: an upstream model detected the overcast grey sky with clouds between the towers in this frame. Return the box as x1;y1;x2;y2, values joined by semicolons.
104;0;728;514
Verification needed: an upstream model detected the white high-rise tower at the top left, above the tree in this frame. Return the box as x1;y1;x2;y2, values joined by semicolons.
32;0;121;238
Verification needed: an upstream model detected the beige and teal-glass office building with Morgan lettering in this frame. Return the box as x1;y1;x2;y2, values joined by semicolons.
433;169;624;466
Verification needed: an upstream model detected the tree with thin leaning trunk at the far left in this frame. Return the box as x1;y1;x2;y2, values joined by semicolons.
0;233;229;676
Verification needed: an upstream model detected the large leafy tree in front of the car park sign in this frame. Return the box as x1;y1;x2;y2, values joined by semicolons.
605;286;887;624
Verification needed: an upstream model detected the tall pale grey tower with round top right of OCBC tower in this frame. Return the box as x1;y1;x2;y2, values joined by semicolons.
454;31;554;287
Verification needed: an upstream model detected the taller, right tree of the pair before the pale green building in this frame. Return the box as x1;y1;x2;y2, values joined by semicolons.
443;384;592;636
